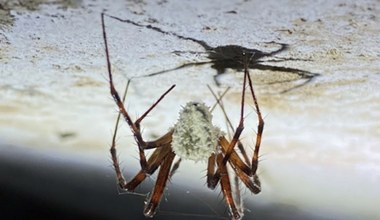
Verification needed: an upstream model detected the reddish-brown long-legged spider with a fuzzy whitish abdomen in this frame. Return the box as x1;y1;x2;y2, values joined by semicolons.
101;13;264;220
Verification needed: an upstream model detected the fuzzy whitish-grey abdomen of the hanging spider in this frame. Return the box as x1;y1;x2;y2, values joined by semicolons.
172;102;221;161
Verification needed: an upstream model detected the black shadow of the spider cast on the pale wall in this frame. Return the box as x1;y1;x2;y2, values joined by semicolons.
103;15;319;93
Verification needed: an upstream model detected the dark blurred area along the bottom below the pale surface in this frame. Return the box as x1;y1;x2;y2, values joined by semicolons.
0;146;330;220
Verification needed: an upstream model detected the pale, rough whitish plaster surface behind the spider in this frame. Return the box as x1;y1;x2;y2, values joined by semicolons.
0;0;380;219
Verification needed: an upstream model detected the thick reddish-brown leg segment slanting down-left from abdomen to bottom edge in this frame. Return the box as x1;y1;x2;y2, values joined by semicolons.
144;148;175;218
